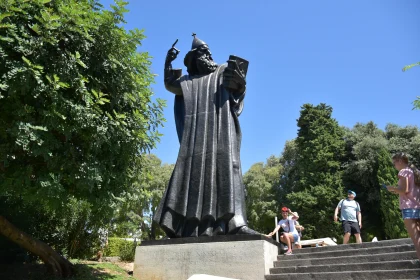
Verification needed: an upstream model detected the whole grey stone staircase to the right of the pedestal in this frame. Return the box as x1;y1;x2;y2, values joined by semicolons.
265;238;420;280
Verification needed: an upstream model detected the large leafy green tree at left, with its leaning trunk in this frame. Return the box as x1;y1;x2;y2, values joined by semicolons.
0;0;164;276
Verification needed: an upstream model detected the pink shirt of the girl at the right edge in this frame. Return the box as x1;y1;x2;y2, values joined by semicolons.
398;167;420;209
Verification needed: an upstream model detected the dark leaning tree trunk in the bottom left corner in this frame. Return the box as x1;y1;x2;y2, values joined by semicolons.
0;215;73;277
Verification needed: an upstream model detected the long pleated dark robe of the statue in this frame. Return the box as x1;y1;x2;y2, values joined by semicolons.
154;65;247;238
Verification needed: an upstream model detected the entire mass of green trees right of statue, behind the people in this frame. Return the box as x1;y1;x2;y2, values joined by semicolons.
244;104;420;242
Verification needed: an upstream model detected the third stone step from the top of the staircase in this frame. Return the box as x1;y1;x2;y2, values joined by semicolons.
274;251;417;267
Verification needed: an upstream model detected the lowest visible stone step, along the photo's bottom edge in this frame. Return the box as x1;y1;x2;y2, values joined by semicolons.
265;266;420;280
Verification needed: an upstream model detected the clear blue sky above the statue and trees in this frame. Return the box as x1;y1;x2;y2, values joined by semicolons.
102;0;420;172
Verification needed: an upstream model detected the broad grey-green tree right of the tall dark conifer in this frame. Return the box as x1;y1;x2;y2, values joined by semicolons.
343;122;420;240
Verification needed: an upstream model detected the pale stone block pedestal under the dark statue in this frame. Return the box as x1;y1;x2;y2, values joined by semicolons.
134;235;278;280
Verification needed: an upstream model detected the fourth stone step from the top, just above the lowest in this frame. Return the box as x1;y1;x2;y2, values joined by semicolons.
270;260;420;274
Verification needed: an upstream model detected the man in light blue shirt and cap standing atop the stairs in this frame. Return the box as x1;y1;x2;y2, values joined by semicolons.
334;190;362;244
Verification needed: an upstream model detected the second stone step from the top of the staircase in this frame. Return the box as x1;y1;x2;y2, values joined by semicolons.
277;244;415;261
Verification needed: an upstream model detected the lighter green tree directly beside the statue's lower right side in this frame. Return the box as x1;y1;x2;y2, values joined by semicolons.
243;156;282;233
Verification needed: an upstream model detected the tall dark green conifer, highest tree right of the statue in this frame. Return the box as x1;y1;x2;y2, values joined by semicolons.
287;104;344;238
